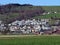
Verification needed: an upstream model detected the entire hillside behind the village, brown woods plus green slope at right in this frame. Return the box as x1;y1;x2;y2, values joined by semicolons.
0;4;60;23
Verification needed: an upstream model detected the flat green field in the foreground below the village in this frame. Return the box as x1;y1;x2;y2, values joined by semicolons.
0;35;60;45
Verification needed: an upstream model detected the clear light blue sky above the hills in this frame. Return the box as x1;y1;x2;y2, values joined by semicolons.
0;0;60;6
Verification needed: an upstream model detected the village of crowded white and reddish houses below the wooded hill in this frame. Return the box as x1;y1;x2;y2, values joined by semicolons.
0;19;60;35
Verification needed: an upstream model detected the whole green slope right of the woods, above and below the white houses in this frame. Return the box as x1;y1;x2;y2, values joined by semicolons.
34;6;60;19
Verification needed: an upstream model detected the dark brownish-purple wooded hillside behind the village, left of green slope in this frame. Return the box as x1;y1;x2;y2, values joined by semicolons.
0;4;44;23
